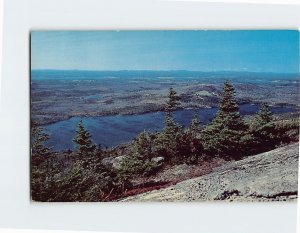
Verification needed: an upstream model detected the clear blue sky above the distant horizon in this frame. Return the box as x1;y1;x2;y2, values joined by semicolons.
31;30;299;73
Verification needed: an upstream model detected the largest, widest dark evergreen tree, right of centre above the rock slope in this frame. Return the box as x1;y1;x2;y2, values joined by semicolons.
202;81;248;159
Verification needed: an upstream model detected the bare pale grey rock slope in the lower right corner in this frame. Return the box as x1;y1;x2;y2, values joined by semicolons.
121;143;299;202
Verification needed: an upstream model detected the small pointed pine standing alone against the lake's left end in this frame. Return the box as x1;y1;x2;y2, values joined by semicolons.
73;120;96;156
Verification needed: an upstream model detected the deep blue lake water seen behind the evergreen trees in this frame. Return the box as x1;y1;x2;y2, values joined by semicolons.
44;104;295;151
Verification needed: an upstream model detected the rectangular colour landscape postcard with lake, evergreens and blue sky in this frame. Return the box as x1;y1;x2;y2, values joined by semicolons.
30;30;300;202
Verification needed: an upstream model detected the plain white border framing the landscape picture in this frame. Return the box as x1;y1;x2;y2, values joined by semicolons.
0;0;300;233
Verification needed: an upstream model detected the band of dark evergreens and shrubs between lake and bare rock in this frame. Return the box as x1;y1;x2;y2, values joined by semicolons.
31;81;299;201
